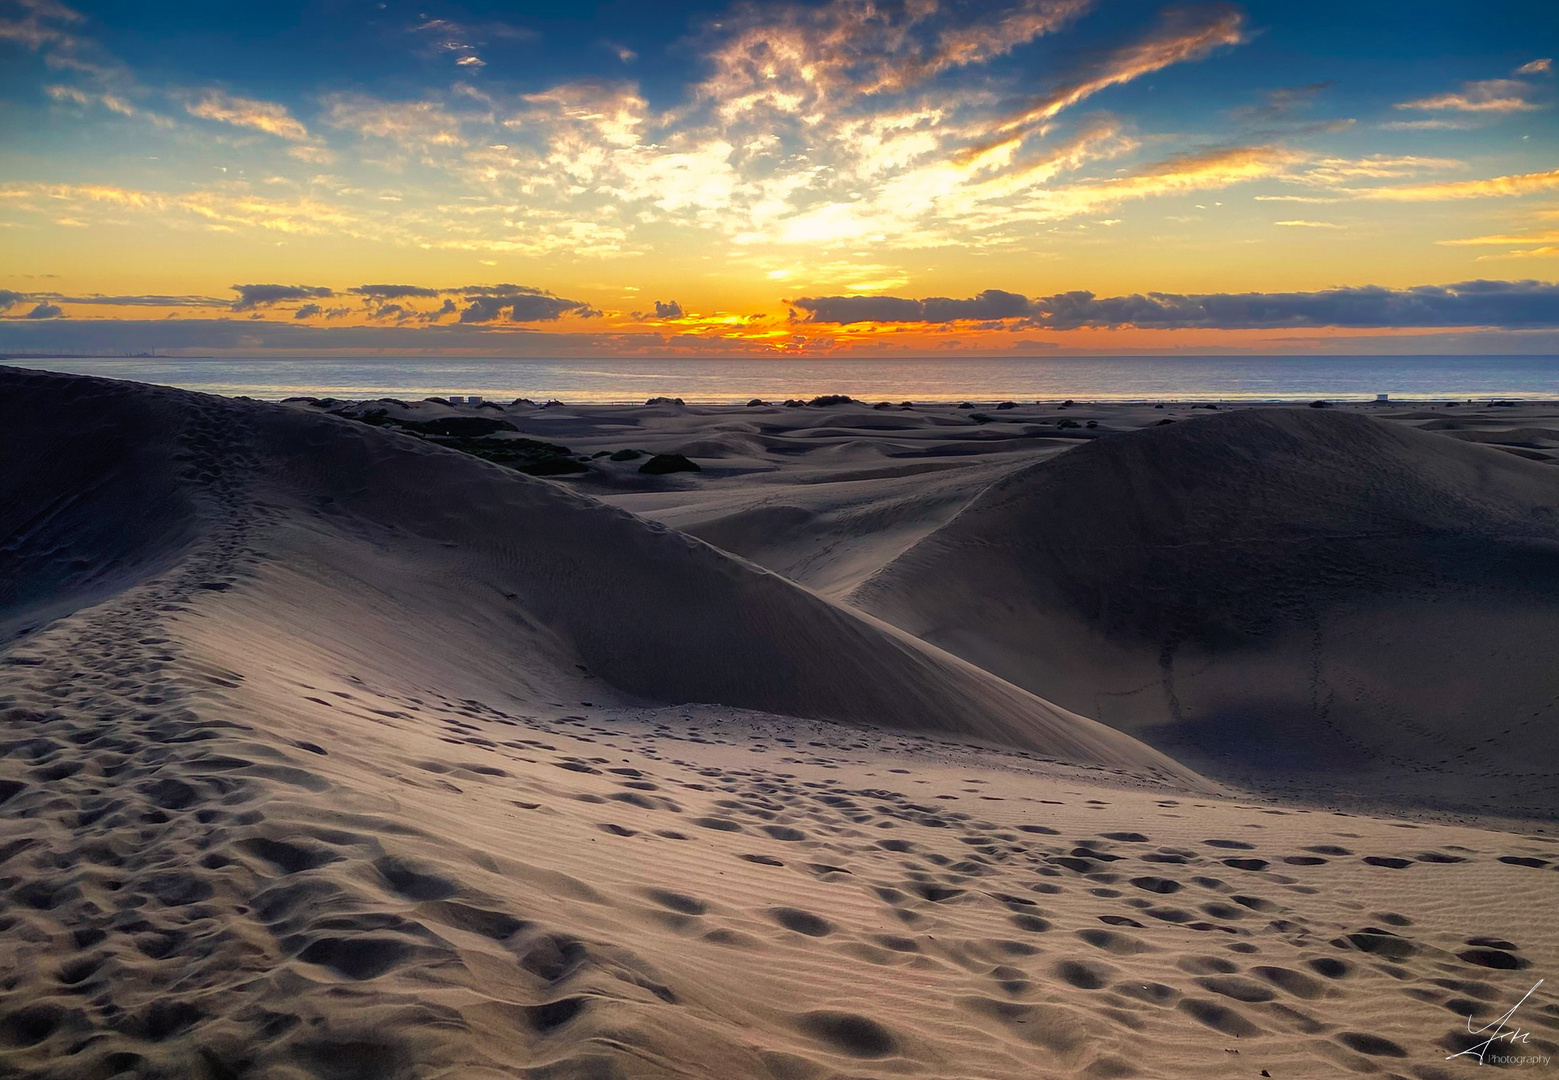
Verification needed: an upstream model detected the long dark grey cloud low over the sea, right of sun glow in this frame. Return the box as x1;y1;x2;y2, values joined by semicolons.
790;281;1559;330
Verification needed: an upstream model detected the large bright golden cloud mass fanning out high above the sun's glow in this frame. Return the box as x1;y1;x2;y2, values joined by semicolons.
0;0;1265;261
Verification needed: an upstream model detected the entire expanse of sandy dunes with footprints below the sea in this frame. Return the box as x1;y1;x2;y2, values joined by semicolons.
0;368;1559;1080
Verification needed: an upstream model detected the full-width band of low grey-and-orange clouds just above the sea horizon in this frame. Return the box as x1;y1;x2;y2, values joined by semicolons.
0;279;1559;355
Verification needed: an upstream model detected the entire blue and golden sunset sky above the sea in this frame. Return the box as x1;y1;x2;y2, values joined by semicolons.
0;0;1559;357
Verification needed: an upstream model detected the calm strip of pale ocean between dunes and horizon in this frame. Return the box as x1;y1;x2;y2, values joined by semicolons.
6;355;1559;404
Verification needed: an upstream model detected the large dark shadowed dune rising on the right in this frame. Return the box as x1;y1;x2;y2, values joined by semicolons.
851;410;1559;814
